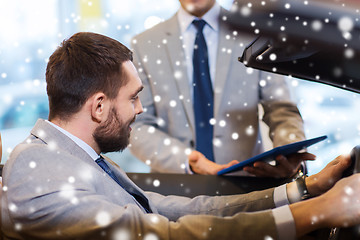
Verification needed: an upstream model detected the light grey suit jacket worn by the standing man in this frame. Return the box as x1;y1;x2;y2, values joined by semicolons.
130;6;305;173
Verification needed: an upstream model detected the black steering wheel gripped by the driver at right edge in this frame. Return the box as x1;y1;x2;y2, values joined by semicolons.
328;145;360;240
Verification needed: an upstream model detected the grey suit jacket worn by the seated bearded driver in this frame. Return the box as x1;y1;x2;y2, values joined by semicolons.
1;120;277;240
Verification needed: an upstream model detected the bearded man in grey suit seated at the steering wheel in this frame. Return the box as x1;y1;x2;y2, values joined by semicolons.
1;33;360;240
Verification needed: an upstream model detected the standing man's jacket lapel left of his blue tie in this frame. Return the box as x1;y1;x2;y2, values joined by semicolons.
164;14;195;128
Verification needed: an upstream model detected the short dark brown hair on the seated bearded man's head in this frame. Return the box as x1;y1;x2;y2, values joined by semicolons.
46;32;132;120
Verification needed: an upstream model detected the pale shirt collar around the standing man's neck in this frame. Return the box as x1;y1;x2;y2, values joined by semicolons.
177;2;221;33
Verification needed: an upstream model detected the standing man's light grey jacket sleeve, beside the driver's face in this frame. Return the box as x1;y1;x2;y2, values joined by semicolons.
129;36;191;173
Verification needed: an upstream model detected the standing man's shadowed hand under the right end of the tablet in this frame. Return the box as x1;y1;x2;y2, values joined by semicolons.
244;152;316;178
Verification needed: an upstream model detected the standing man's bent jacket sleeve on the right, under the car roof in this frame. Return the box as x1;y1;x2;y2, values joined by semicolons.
259;72;305;147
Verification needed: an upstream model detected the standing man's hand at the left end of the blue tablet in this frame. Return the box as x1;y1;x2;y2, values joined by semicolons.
188;151;238;175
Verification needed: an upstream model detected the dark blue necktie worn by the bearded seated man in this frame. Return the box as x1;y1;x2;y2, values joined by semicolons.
95;156;152;213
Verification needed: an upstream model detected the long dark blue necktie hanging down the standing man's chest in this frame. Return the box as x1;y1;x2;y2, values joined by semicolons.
193;19;214;161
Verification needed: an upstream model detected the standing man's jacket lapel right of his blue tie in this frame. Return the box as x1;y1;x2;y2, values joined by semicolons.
214;8;238;118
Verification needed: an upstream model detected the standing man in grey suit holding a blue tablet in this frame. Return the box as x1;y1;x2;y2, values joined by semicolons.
130;0;305;177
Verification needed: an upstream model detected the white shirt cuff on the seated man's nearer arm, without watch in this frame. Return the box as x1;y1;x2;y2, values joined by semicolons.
272;205;296;240
